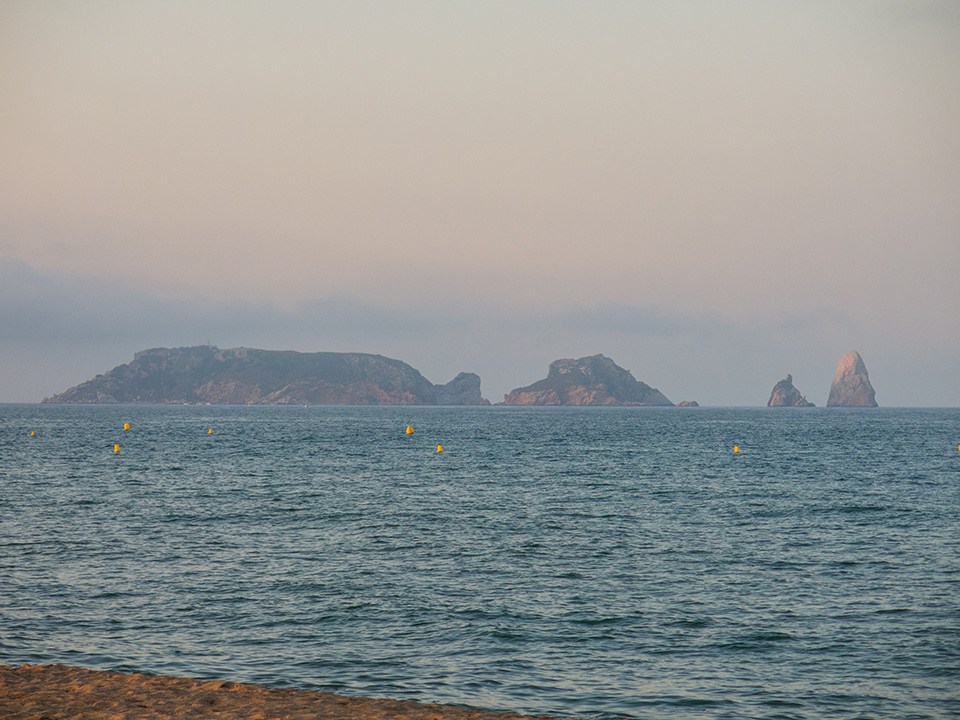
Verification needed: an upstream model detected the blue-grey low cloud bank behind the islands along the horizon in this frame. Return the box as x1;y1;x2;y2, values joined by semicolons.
0;259;960;406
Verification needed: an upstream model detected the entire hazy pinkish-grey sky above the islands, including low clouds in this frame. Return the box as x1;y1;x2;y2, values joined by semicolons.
0;0;960;407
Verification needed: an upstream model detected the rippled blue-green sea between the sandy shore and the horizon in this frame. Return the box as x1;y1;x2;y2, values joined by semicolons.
0;405;960;720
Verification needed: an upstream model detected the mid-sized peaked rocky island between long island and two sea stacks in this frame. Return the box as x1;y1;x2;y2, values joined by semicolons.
503;355;673;405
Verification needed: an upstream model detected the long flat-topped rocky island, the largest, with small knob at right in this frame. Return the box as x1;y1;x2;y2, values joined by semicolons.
43;345;489;405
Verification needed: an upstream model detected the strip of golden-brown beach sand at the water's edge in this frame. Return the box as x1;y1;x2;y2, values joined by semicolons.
0;665;564;720
